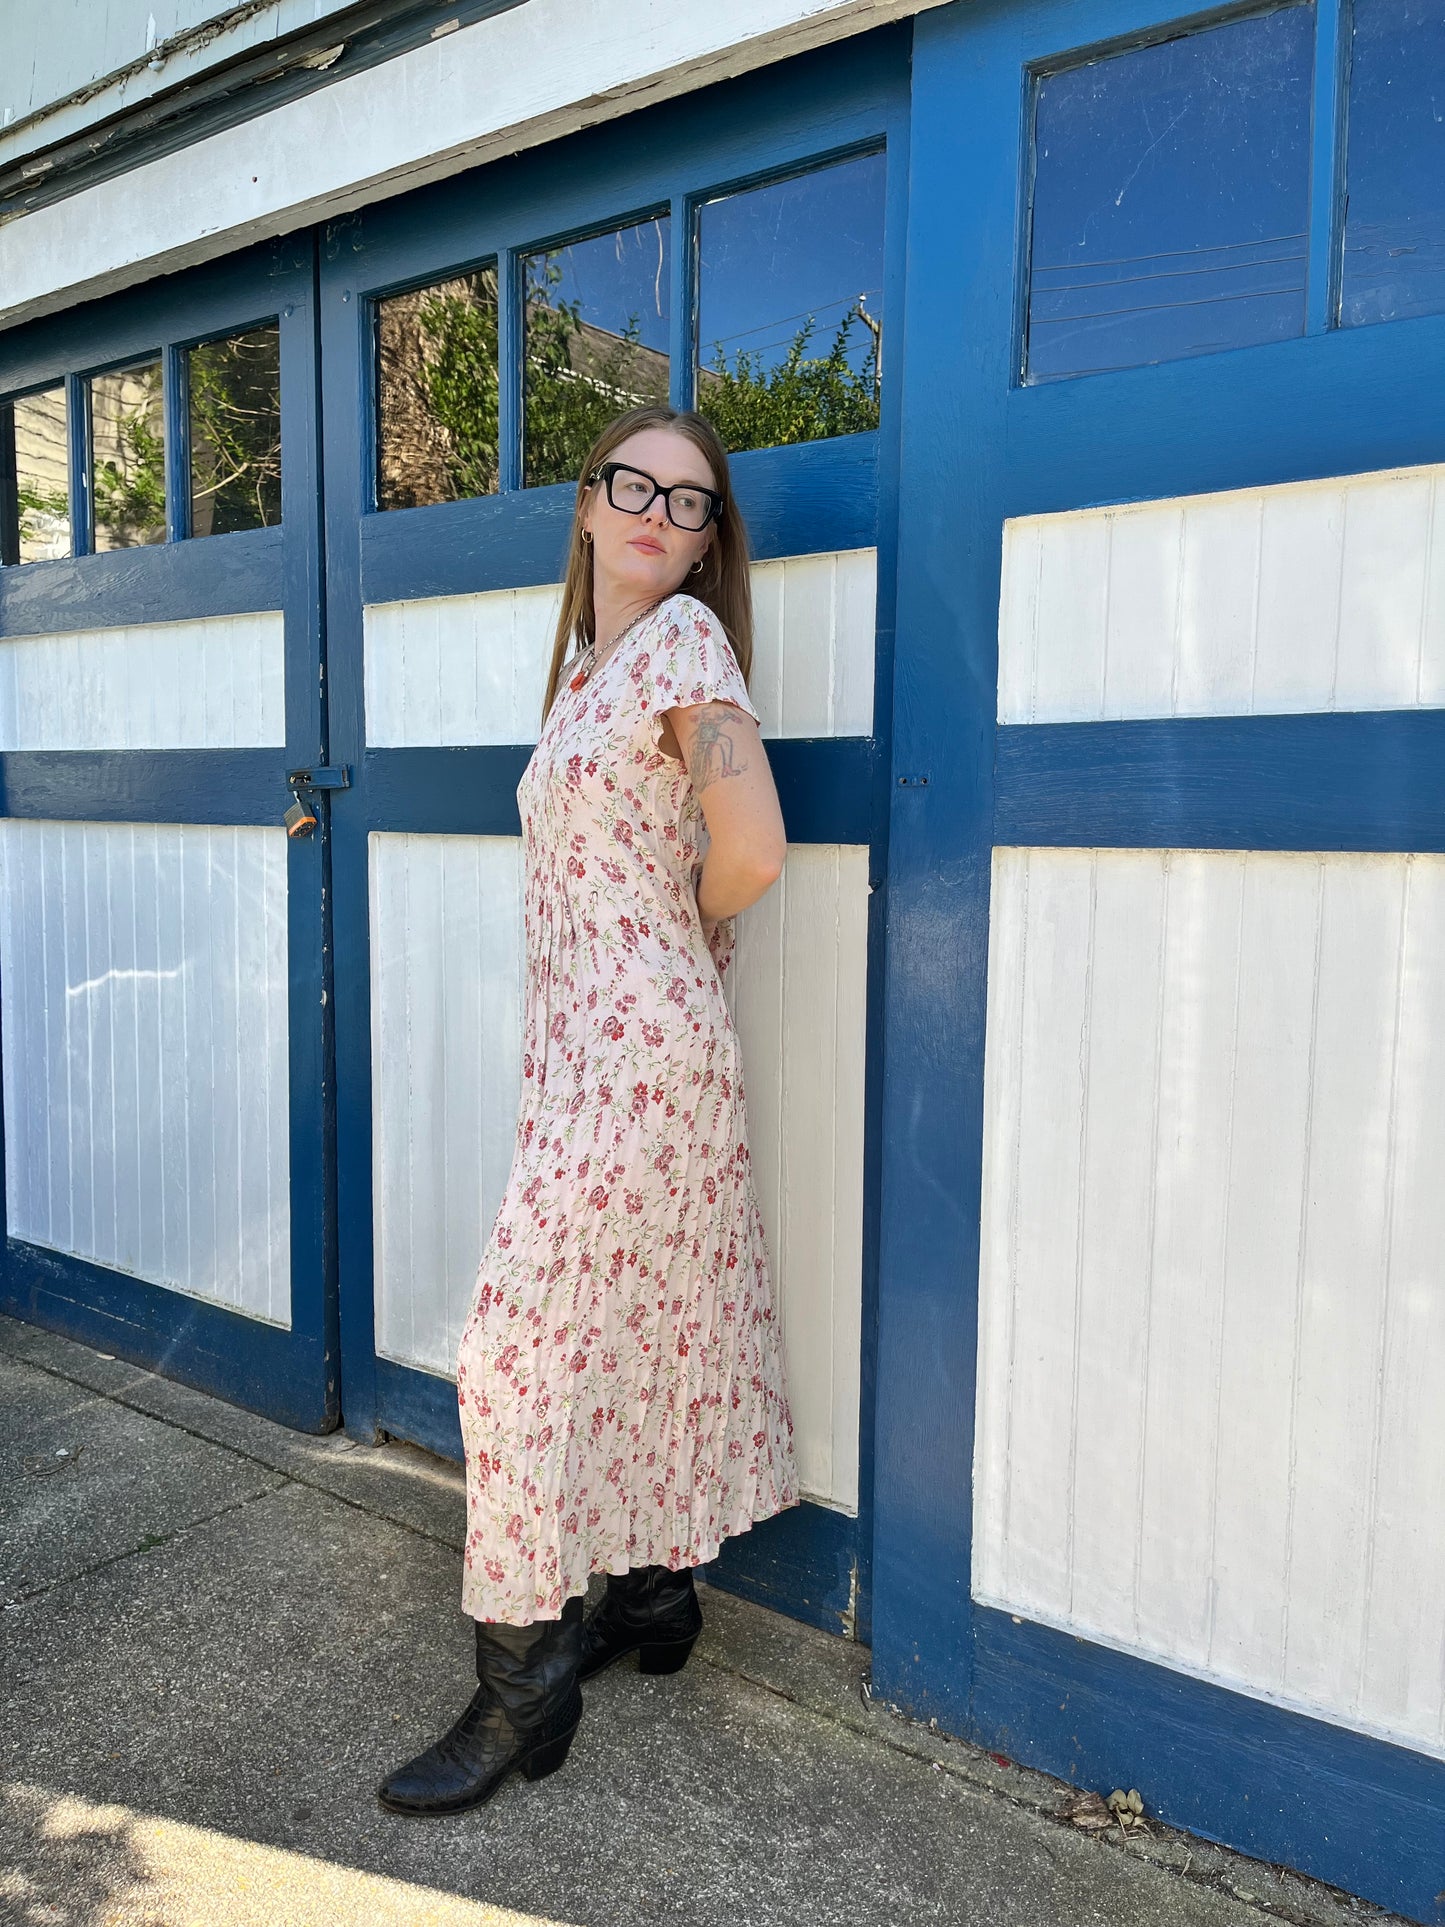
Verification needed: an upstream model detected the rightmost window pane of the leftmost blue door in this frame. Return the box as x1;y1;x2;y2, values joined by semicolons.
189;324;281;536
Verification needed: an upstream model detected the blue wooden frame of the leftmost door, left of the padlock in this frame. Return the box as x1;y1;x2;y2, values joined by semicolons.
0;235;339;1432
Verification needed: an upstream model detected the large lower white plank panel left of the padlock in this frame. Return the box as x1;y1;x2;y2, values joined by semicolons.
0;819;291;1326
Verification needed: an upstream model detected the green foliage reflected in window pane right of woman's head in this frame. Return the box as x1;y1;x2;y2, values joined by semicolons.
697;303;879;449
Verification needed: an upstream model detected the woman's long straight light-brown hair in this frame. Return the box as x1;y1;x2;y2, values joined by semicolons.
541;403;753;723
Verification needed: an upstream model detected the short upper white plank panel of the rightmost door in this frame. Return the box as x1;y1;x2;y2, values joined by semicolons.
998;464;1445;723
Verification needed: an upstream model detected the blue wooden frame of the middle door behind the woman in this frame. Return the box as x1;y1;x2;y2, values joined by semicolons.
322;27;909;1638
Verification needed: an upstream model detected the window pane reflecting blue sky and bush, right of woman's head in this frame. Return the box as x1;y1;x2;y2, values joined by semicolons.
697;154;884;449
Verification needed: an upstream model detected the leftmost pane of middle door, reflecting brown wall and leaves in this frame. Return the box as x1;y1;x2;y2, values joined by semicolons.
376;266;497;509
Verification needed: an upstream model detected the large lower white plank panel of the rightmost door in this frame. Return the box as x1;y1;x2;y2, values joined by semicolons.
973;850;1445;1754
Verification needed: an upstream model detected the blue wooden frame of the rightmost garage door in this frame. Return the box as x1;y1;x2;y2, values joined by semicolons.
873;0;1445;1921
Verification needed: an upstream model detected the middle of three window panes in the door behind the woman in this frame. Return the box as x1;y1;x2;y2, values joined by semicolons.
524;214;670;488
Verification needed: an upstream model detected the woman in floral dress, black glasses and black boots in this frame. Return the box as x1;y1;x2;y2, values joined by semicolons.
380;407;798;1813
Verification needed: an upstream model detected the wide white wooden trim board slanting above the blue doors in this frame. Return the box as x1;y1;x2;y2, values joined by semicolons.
0;0;942;326
